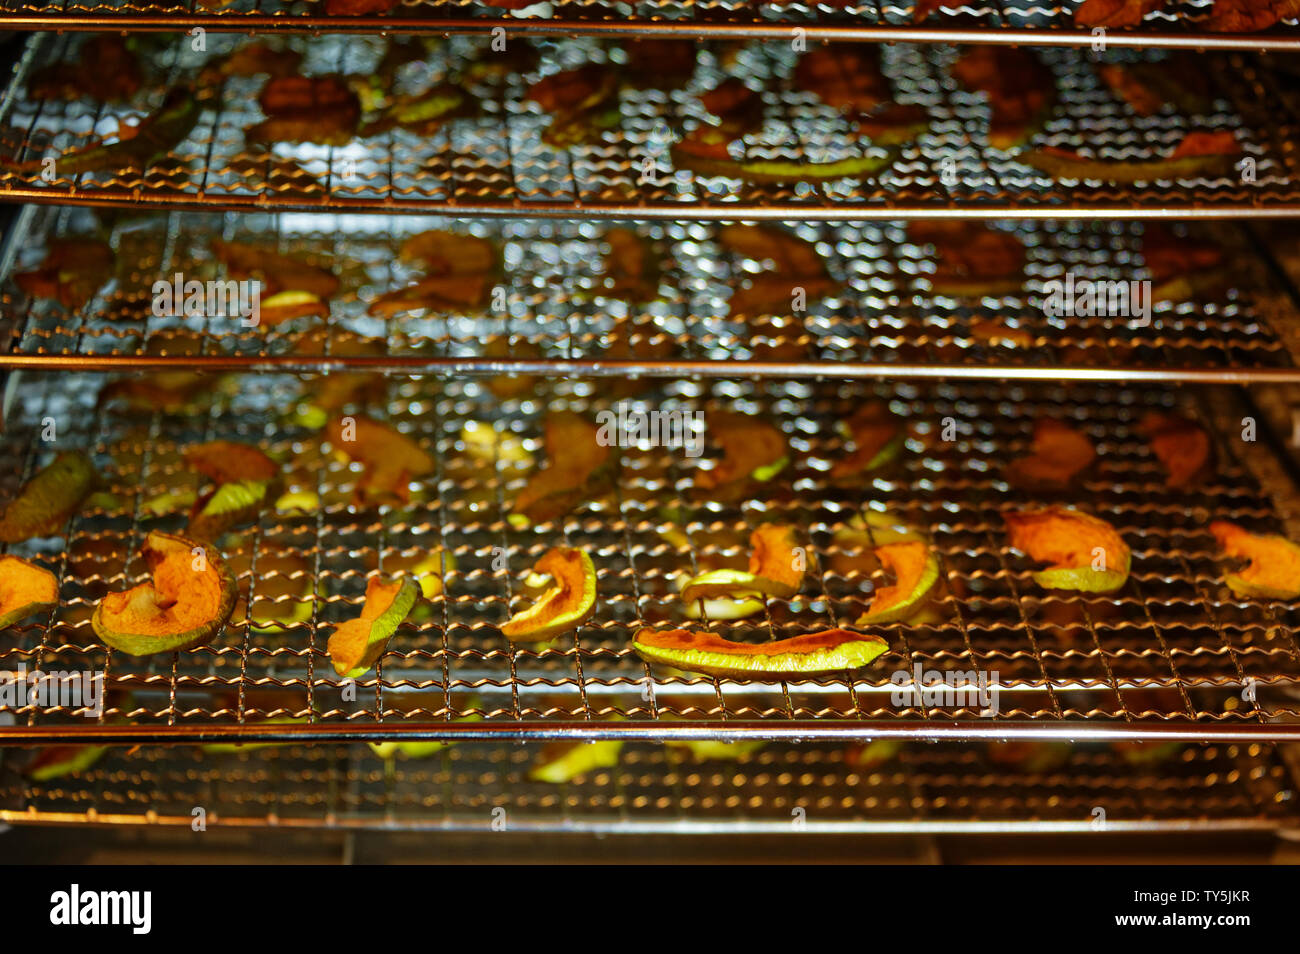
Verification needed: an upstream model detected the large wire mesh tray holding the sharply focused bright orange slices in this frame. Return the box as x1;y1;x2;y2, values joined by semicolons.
0;374;1300;737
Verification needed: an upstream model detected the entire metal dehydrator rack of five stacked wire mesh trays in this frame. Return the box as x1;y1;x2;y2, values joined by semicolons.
0;9;1300;833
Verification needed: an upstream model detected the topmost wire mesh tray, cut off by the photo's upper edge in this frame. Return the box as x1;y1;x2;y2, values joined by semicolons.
0;0;1300;49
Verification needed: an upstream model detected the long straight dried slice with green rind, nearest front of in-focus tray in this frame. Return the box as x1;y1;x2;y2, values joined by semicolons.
632;629;889;680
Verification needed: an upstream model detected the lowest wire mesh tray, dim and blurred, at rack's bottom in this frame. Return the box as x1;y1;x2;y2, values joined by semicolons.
0;742;1296;833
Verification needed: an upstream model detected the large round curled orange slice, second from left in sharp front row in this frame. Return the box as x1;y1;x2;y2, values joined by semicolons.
91;530;238;656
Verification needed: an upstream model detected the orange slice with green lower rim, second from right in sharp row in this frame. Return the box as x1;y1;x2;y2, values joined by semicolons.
1004;507;1132;593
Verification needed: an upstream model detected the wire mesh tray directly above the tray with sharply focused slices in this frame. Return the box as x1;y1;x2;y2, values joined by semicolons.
0;209;1294;374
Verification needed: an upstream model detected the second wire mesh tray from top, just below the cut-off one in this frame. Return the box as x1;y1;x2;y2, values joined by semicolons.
0;36;1300;220
